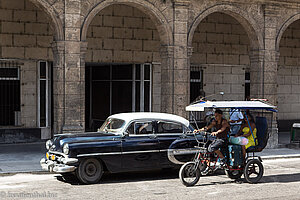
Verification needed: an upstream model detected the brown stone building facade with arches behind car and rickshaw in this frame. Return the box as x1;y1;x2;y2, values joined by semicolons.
0;0;300;147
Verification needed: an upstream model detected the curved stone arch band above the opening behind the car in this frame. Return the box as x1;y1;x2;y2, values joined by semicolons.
81;0;172;45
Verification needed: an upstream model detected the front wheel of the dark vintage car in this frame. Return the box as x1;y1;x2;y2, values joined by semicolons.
76;158;103;184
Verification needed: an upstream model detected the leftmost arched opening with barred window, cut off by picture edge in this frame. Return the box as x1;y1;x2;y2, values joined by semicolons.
0;0;63;143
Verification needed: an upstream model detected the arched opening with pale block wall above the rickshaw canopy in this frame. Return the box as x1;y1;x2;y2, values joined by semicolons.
191;12;253;101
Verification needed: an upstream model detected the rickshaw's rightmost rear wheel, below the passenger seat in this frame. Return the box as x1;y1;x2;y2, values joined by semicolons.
244;159;264;183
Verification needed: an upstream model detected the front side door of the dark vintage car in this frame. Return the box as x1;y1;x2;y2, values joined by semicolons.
122;120;159;171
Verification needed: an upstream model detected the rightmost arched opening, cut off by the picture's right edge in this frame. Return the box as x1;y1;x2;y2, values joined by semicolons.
277;17;300;132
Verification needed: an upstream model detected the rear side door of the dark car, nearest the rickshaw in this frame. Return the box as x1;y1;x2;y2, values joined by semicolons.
156;121;185;168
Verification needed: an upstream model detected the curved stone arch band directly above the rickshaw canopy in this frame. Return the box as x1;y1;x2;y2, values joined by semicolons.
188;4;263;49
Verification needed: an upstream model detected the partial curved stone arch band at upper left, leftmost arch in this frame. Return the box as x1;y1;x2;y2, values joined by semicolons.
29;0;64;41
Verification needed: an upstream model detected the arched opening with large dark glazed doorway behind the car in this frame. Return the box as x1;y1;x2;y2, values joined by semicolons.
83;4;169;130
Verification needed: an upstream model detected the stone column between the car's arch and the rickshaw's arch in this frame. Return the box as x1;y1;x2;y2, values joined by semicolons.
162;0;190;117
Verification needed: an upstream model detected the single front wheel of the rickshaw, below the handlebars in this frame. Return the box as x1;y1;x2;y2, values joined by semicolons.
179;162;201;187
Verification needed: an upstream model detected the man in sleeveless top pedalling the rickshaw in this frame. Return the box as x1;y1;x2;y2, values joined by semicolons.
195;109;230;165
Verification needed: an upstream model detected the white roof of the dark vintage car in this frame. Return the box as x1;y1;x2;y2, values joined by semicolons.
109;112;190;127
